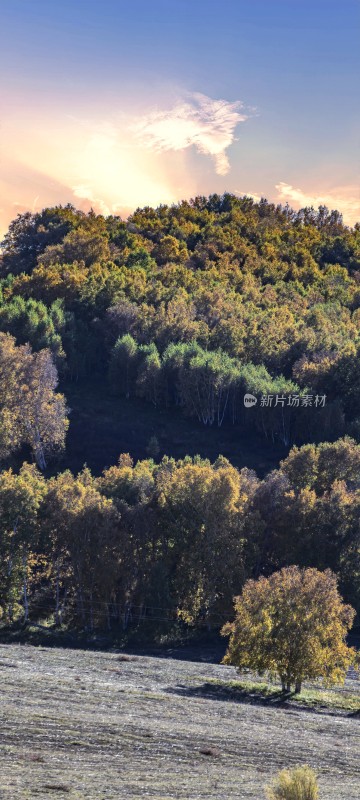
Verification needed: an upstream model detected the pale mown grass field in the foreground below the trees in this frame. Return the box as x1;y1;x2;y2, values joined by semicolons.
0;644;360;800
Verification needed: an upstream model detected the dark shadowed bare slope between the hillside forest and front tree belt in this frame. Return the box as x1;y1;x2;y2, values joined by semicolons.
57;379;287;476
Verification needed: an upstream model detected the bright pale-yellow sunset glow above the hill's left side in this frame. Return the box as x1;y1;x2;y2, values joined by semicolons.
0;108;184;230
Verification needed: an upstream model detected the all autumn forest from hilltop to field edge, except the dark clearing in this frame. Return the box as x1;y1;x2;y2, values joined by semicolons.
0;194;360;628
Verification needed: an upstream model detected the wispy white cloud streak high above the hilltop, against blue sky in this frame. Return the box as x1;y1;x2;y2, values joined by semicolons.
131;92;248;175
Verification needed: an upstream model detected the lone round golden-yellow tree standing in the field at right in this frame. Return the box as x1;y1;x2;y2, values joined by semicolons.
222;566;357;692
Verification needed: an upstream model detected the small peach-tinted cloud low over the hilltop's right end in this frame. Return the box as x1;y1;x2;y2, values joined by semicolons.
275;181;360;225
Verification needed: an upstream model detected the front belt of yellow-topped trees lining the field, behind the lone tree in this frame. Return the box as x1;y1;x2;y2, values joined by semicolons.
0;439;360;628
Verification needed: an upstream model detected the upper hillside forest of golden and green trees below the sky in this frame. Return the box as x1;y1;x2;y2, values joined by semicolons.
0;194;360;442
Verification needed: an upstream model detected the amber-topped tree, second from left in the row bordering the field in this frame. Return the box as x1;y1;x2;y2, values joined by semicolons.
45;467;123;630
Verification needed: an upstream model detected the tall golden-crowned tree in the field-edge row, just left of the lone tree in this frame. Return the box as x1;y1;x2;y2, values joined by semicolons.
157;458;247;625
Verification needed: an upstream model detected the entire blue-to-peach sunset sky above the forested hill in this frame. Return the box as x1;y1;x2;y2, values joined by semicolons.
0;0;360;235
